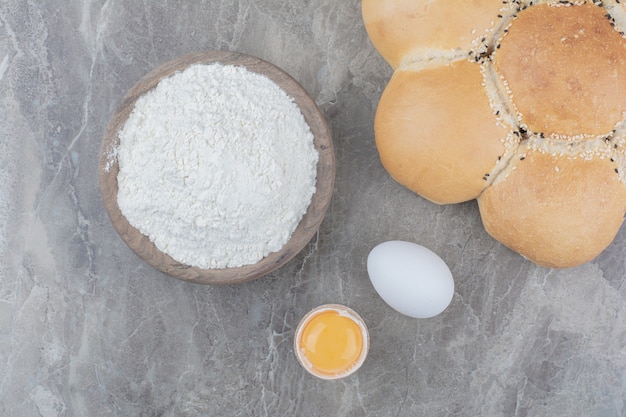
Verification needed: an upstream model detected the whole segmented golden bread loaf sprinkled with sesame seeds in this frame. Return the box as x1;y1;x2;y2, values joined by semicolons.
362;0;626;268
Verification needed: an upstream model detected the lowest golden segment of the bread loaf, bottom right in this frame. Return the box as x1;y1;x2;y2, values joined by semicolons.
478;150;626;268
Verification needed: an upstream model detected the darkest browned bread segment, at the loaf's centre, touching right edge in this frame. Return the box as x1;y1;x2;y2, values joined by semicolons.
494;4;626;136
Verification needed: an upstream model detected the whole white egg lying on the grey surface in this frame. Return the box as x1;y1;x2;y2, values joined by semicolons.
367;240;454;318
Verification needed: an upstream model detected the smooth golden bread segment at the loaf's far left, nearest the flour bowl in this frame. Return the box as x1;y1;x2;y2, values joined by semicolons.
374;61;507;204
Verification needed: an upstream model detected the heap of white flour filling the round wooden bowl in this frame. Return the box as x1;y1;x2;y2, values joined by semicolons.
117;64;318;269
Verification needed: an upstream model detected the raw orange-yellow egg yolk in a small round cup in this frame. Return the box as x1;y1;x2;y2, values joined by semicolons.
299;310;363;375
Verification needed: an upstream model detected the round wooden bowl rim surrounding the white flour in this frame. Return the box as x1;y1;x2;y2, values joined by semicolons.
98;51;335;284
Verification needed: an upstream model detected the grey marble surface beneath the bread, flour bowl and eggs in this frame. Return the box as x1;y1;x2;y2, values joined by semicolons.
0;0;626;417
